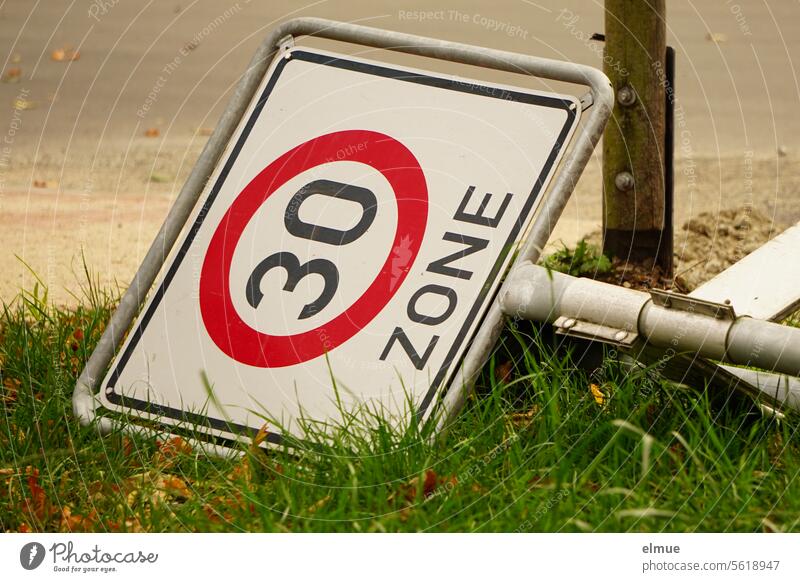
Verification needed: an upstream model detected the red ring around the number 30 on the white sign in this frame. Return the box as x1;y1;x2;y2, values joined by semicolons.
200;130;428;368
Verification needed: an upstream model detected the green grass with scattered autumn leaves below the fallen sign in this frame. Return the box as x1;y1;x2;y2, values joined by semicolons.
0;278;800;532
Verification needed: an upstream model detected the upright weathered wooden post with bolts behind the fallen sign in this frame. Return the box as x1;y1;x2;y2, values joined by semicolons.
603;0;672;276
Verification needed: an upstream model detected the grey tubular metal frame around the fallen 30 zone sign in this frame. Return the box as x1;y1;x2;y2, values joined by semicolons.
73;18;614;455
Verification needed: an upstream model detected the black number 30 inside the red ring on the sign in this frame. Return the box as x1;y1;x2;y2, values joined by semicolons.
245;180;378;319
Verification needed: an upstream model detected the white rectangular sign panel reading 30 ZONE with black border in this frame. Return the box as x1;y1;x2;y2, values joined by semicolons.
101;49;580;442
